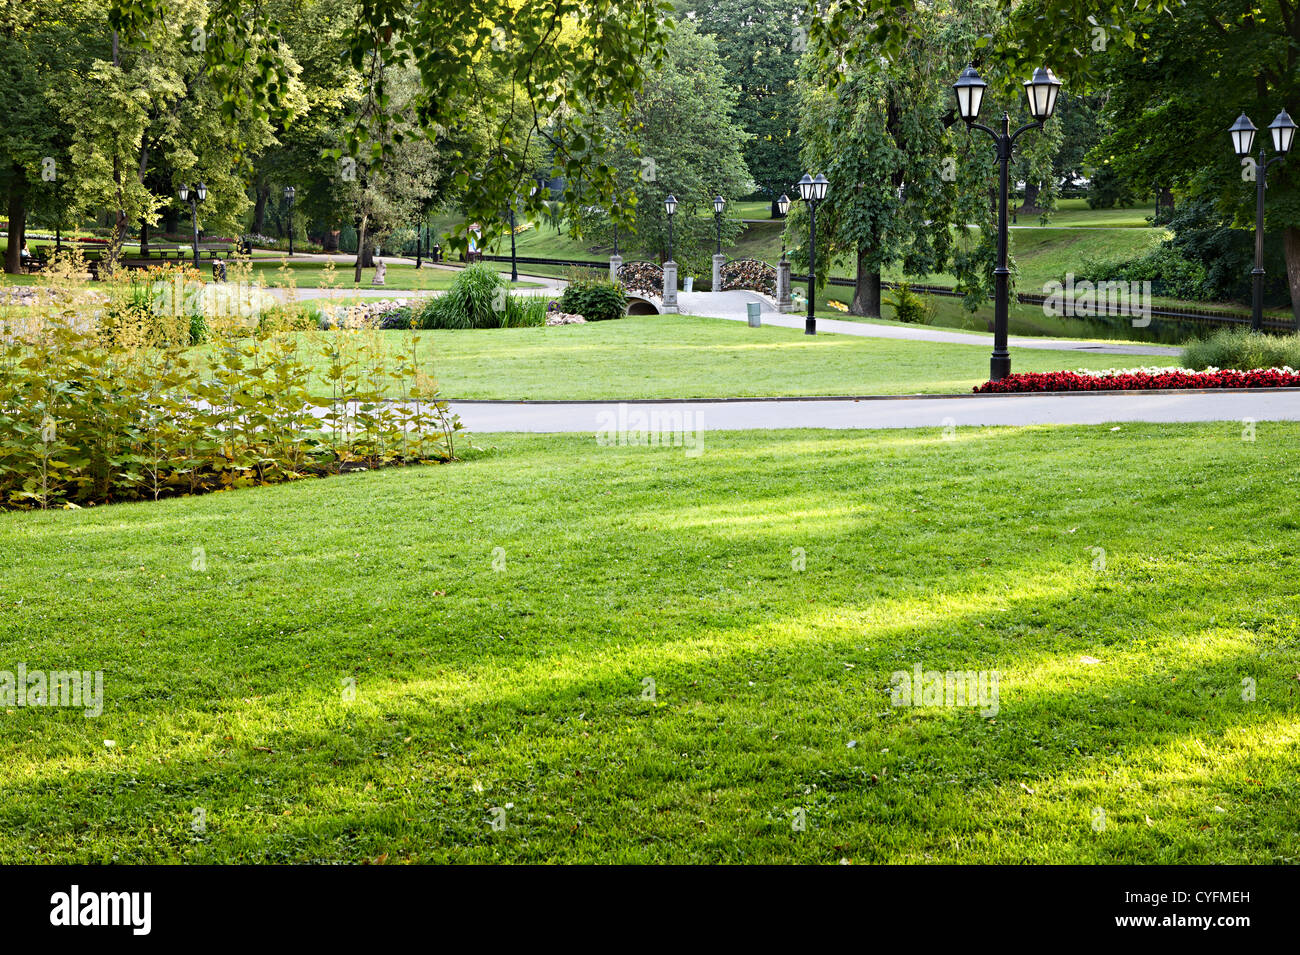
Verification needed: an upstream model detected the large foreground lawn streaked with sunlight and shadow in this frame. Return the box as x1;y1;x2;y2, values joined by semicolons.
0;422;1300;864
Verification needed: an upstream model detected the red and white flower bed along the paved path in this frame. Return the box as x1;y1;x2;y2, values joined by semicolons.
974;368;1300;395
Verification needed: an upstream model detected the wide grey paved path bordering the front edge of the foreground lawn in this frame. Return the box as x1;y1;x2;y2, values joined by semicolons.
451;390;1300;434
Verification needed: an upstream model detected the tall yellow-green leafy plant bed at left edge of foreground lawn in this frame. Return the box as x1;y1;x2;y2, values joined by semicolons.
0;277;460;508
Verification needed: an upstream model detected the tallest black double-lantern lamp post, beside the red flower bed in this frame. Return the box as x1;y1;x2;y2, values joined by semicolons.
953;66;1061;381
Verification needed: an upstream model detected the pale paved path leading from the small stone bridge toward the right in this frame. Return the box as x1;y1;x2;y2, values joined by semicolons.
677;291;1182;357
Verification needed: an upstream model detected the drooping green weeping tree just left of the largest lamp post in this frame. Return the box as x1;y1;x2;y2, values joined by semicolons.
787;3;996;317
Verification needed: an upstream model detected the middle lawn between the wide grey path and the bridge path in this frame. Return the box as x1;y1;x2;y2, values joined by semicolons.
271;316;1177;400
